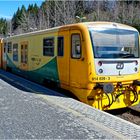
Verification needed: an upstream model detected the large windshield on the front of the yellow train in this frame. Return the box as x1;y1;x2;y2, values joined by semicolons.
90;28;139;58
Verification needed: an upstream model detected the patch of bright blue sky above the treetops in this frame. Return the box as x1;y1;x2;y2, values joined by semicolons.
0;0;45;19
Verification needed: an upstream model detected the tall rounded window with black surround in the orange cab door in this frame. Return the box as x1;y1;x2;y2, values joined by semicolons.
71;34;81;59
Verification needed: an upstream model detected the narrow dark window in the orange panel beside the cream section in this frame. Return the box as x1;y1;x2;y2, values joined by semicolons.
57;37;64;56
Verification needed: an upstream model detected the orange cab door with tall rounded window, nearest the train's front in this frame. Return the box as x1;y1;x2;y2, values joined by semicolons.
70;30;86;88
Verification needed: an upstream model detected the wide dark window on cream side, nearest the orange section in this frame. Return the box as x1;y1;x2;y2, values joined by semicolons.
43;37;54;56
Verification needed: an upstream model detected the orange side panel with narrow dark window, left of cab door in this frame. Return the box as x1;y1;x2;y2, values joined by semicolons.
57;30;70;89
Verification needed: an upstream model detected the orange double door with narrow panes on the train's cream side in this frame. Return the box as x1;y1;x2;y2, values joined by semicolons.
20;42;28;70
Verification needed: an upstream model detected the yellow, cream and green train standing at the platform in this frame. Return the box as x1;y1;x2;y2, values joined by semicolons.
0;22;140;110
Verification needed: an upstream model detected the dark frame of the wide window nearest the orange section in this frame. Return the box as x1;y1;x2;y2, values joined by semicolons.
43;37;55;57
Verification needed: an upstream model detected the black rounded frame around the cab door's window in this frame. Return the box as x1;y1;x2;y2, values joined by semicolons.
71;33;82;59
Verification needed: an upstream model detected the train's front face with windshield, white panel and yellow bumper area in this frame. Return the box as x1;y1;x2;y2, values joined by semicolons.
87;23;140;110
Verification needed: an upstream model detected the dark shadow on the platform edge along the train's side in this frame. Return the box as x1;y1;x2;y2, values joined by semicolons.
0;70;78;100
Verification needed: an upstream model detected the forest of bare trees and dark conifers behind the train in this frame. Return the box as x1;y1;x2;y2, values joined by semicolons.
0;0;140;36
